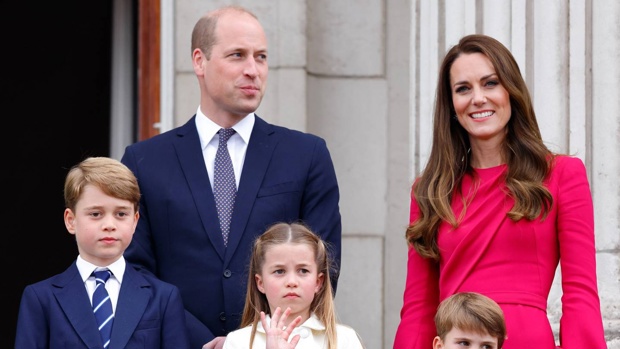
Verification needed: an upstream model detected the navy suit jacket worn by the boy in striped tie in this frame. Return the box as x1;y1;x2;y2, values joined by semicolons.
15;262;190;349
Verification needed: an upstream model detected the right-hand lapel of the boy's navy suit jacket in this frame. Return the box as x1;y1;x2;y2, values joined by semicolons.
109;264;152;349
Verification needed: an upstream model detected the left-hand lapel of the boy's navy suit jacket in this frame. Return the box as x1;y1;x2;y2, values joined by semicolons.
52;262;101;348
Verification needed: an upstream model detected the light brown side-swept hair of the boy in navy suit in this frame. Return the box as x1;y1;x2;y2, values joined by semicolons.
64;157;140;212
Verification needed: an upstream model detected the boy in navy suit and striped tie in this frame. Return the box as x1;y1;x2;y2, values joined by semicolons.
15;157;189;349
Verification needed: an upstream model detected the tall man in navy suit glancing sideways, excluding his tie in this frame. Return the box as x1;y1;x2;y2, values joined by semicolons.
121;6;341;349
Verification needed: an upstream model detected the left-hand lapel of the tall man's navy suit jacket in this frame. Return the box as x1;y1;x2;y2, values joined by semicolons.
173;115;225;260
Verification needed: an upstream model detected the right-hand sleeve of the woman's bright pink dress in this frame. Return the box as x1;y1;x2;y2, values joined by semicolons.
549;157;607;349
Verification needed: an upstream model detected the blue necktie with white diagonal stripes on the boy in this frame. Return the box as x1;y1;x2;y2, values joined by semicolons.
93;269;114;348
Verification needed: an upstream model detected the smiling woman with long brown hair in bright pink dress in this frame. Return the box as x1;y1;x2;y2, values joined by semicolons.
394;35;607;349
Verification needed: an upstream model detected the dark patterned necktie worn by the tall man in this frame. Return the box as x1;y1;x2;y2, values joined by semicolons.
213;128;237;246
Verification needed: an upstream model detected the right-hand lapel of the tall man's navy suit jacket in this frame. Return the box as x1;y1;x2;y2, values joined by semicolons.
224;116;280;263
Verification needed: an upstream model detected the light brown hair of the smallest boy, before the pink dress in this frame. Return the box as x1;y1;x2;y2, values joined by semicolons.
435;292;506;348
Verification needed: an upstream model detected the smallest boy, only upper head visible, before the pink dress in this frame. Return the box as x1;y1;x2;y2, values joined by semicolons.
433;292;506;349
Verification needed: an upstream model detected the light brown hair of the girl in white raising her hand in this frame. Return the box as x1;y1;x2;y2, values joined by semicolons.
240;223;336;349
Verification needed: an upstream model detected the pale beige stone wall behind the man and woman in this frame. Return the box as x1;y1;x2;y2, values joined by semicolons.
162;0;620;349
